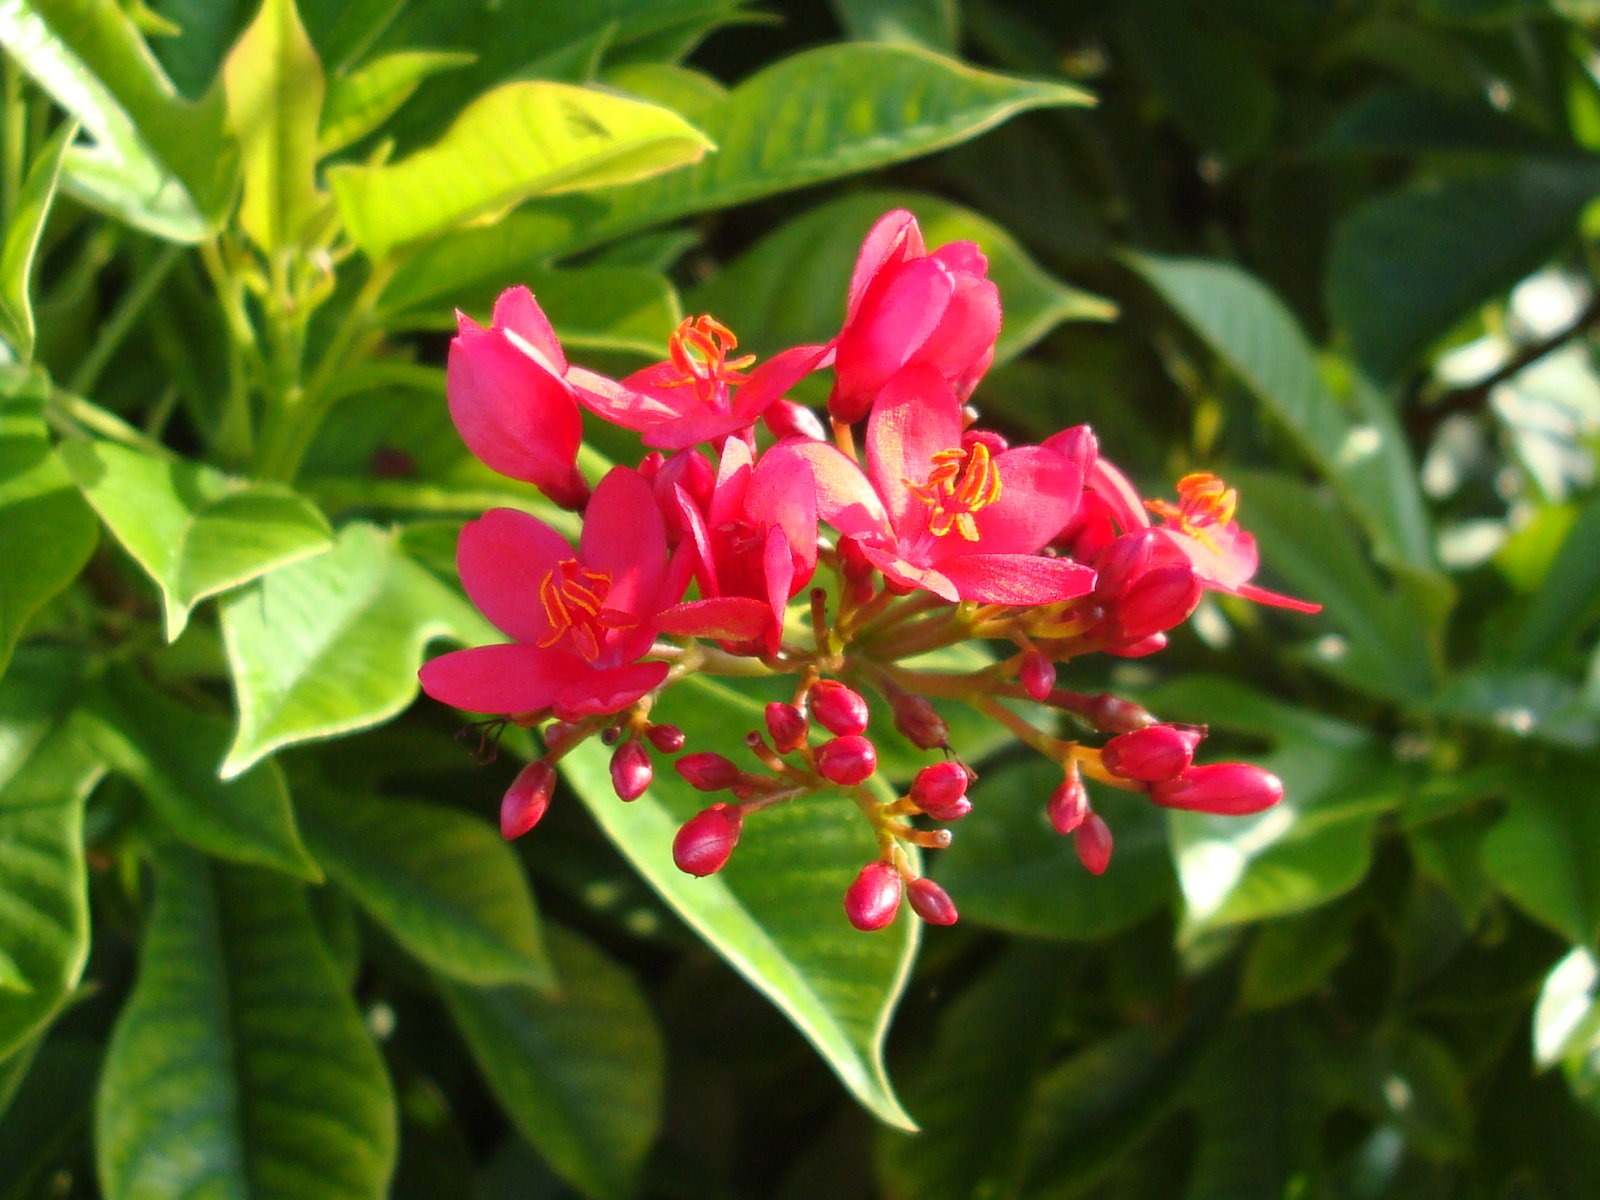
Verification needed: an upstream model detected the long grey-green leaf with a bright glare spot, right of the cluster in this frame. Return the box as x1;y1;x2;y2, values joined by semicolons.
1128;254;1432;570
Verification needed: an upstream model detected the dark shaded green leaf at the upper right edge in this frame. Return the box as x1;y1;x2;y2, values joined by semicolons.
1326;160;1600;381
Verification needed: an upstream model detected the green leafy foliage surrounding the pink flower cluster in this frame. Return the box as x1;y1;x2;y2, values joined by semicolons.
0;0;1600;1200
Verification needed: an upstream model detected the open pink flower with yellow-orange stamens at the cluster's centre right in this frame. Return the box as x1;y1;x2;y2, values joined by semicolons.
768;365;1094;605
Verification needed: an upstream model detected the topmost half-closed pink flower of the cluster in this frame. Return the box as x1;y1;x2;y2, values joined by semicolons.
827;208;1000;422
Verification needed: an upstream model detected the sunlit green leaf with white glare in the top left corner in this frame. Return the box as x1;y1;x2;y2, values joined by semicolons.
0;0;238;242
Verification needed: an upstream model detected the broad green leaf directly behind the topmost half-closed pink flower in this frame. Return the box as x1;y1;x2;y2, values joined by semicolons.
688;192;1117;363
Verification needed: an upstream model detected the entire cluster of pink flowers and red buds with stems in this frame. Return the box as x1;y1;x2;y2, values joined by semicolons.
421;211;1317;930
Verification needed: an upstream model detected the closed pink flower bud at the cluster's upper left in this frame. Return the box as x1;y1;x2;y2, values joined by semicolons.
445;286;589;509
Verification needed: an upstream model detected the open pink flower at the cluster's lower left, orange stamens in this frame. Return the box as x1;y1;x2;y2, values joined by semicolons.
421;467;686;720
